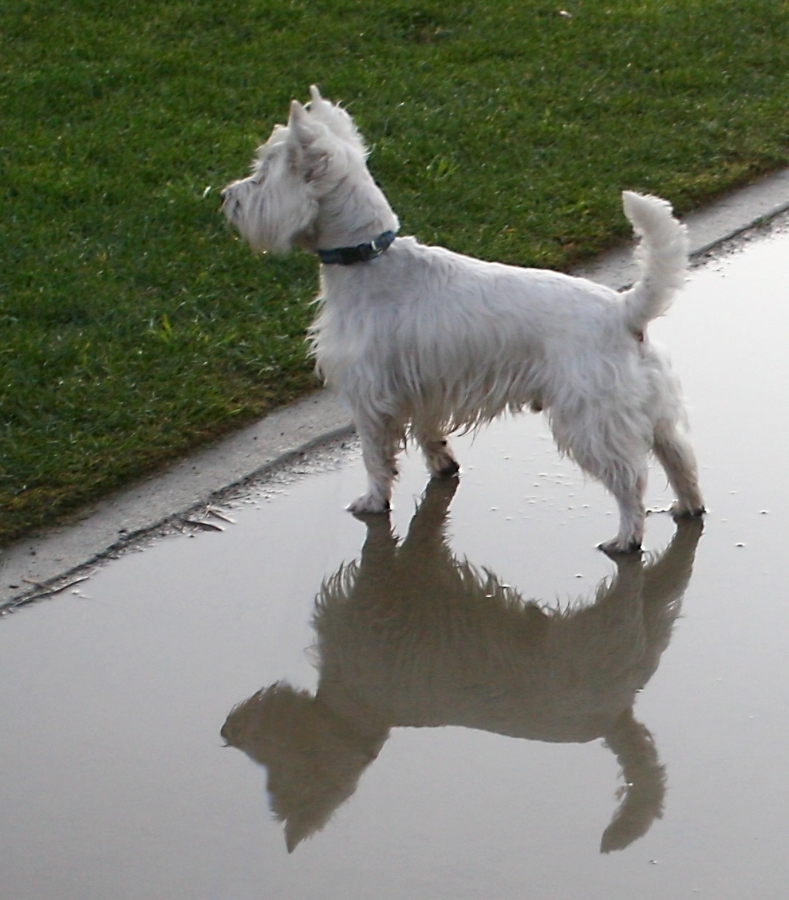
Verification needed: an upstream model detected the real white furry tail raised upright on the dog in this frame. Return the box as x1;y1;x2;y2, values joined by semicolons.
622;191;688;332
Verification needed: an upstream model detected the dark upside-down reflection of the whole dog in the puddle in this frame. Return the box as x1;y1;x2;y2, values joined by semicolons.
222;479;702;853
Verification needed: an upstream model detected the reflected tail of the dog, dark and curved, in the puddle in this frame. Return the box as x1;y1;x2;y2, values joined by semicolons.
600;709;666;853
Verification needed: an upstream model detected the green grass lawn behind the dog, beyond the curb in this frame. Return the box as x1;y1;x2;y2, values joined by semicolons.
0;0;789;543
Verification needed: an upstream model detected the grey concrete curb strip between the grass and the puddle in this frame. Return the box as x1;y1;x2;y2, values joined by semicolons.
0;170;789;611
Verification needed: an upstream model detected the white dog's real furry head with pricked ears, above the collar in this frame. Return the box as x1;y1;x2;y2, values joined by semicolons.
222;86;389;253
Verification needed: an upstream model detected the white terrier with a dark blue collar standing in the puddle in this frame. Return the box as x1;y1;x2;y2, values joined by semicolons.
222;87;704;553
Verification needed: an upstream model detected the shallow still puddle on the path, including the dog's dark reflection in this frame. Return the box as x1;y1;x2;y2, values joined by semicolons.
0;220;789;900
